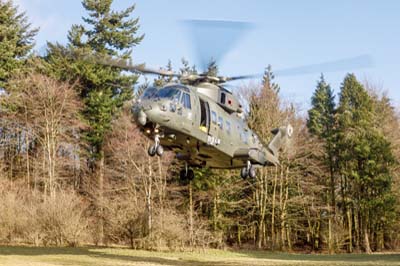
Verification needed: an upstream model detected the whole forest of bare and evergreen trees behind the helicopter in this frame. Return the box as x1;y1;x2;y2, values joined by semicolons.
0;0;400;254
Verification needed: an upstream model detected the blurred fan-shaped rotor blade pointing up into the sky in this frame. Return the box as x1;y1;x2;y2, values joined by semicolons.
183;20;252;71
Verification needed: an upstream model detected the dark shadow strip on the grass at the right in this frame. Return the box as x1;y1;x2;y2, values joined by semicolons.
234;251;400;263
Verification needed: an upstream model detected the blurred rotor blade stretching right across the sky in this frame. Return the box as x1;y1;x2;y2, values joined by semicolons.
273;54;375;76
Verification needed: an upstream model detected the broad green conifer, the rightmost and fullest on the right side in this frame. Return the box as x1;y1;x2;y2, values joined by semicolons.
337;74;394;252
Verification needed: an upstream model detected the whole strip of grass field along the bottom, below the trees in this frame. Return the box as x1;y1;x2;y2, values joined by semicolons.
0;247;400;266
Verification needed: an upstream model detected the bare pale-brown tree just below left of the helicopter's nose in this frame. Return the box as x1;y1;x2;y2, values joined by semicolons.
105;106;171;249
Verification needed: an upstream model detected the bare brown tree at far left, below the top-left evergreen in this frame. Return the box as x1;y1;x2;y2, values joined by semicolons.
2;71;80;196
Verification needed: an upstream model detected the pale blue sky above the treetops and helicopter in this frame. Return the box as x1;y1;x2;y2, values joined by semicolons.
14;0;400;109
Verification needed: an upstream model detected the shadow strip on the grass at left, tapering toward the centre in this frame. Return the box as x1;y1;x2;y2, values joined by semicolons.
0;247;238;266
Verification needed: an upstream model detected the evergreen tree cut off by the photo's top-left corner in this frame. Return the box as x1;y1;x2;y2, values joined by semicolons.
0;0;38;88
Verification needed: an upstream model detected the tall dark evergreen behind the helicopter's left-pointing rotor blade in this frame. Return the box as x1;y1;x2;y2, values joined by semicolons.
47;0;143;160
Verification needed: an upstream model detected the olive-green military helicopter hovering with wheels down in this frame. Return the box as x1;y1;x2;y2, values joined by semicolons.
95;21;374;179
